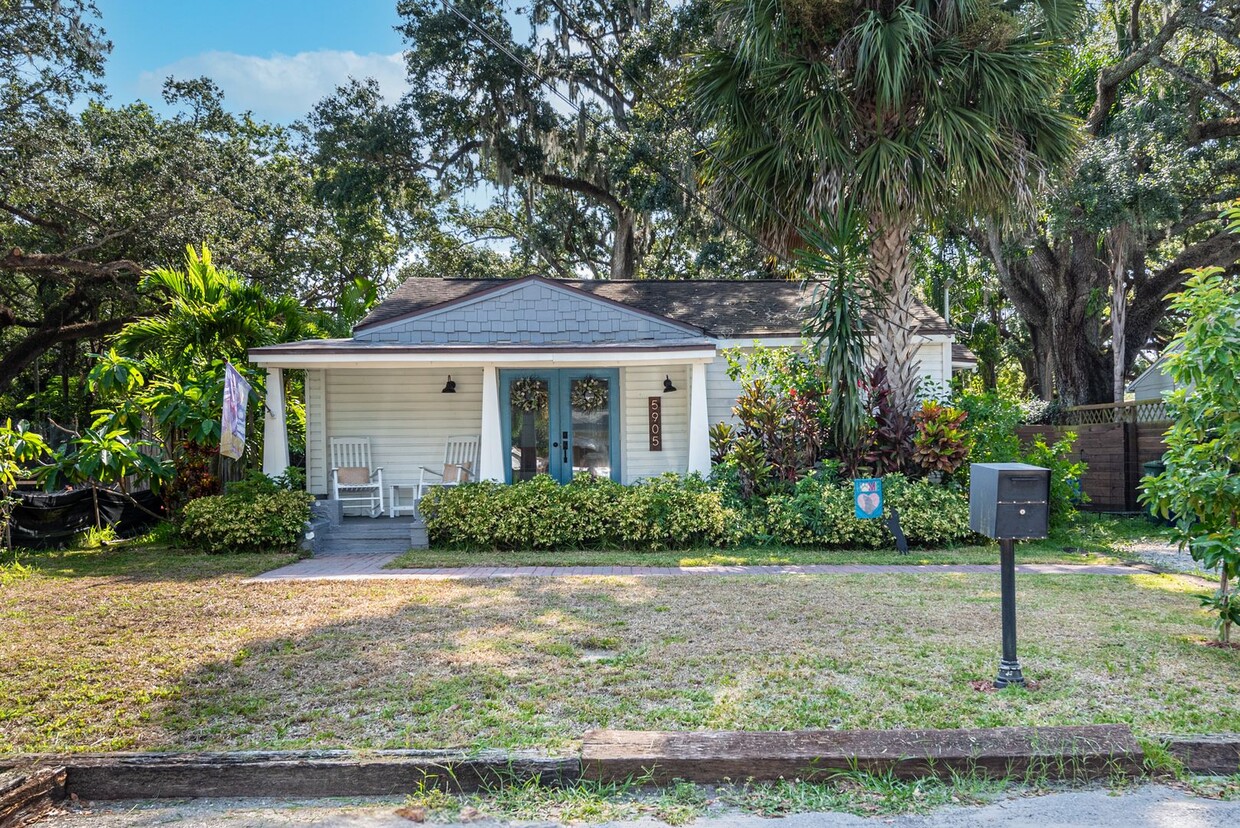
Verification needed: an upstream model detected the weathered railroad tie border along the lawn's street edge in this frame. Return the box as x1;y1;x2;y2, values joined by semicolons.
14;725;1240;803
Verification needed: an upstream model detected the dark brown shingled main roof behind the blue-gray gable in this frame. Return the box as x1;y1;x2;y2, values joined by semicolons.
357;272;951;341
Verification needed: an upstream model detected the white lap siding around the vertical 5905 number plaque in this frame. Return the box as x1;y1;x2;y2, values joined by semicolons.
620;366;689;483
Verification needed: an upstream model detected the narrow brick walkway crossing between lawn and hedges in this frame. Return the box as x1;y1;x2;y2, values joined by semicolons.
244;554;1153;584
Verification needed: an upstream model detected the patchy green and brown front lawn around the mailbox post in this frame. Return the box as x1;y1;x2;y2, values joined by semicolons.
0;530;1240;752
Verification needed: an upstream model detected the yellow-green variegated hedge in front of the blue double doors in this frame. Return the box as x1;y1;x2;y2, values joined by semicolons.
419;475;737;550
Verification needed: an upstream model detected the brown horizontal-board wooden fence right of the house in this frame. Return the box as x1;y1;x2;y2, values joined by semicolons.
1017;399;1171;512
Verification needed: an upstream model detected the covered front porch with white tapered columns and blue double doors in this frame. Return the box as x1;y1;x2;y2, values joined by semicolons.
250;341;715;513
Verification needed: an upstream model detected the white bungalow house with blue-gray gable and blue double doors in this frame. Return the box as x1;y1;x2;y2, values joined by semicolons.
249;276;967;530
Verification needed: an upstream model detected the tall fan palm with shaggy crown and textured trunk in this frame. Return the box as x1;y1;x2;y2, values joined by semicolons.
689;0;1080;412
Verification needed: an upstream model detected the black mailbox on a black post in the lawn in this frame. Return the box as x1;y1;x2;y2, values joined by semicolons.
968;462;1050;687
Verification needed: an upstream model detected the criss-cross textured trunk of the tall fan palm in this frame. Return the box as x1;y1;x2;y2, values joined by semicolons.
869;213;920;414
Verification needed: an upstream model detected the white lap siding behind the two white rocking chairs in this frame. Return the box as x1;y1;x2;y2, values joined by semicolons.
326;368;482;488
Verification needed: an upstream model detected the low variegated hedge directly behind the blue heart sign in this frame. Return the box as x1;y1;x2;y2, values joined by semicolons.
760;475;972;549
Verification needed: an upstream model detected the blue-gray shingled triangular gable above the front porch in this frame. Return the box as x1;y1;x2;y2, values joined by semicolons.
355;279;702;346
